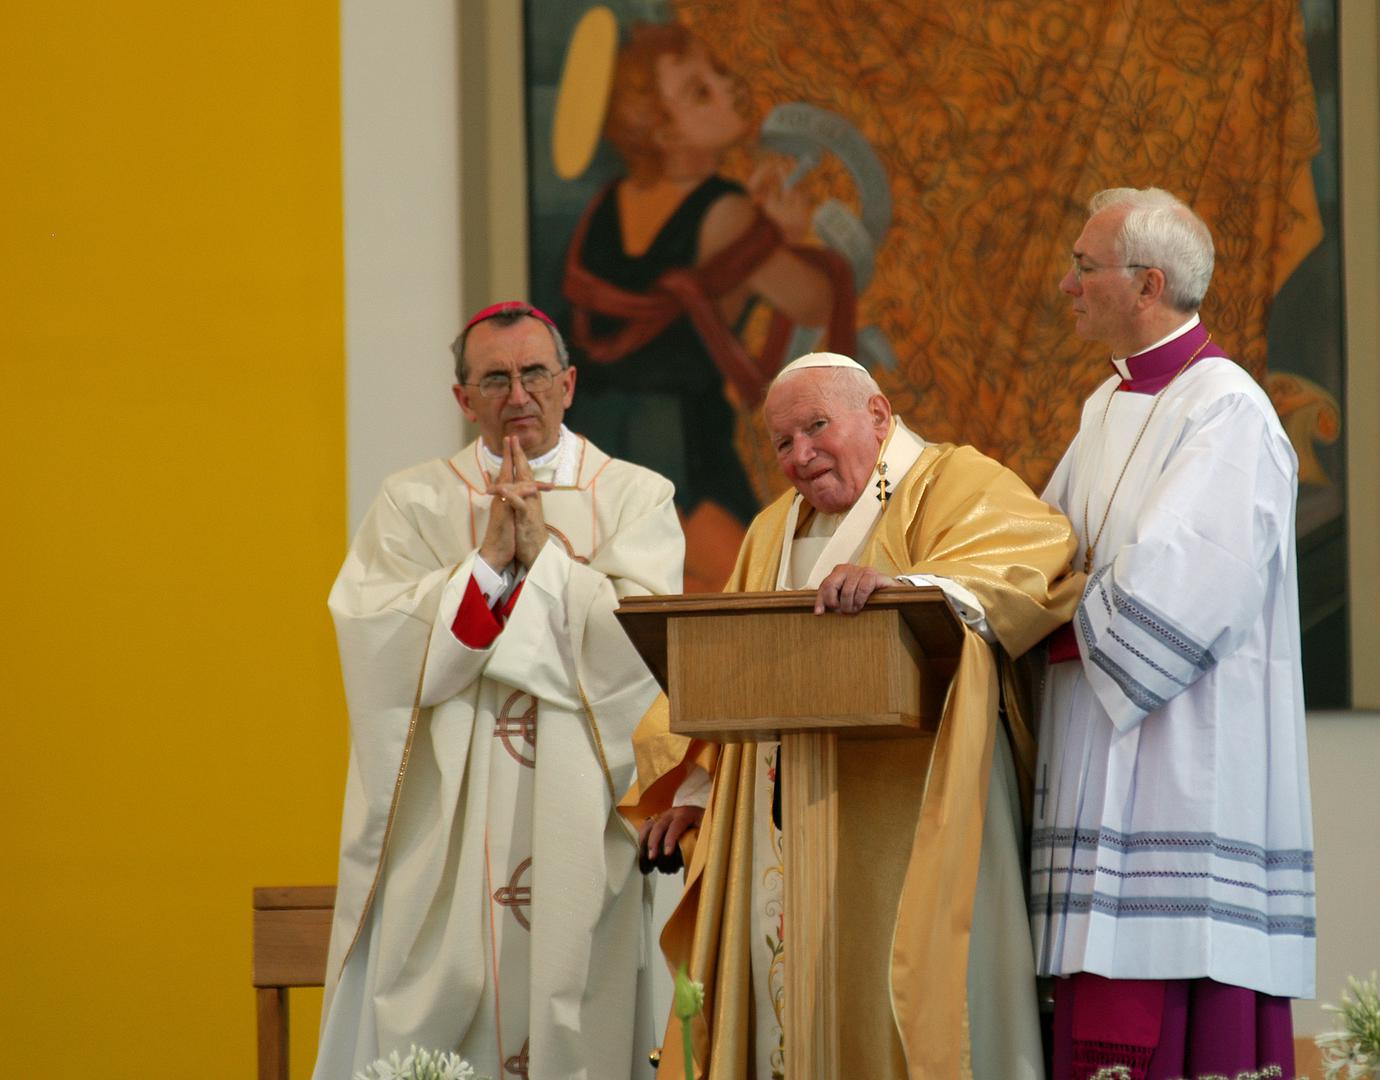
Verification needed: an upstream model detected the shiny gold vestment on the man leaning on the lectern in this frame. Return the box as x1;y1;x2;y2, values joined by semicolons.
622;444;1083;1080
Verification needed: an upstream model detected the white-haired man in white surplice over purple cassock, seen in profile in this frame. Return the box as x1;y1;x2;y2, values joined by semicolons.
1031;188;1315;1080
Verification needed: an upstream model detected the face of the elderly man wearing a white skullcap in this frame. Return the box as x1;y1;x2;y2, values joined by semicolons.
766;368;891;513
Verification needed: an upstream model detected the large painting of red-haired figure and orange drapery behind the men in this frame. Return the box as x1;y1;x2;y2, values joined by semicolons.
526;0;1346;705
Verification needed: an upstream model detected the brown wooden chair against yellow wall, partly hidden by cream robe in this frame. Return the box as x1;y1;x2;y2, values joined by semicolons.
254;886;335;1080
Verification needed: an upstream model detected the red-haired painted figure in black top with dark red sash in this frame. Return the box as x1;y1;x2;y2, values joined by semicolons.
564;23;854;592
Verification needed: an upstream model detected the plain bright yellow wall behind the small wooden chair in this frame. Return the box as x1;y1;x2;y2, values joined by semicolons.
0;0;345;1080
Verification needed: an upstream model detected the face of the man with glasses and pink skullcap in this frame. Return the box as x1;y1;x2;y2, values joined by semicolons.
453;319;575;458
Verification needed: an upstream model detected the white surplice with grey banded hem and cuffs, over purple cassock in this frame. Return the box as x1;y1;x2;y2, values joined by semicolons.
1031;357;1315;997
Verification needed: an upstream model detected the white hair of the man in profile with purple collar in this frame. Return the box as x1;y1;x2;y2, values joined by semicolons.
1087;188;1213;312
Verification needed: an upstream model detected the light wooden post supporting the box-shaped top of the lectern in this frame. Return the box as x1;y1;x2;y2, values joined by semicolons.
780;732;842;1080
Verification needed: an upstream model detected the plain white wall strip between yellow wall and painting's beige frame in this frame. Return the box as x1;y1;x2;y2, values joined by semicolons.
341;0;462;535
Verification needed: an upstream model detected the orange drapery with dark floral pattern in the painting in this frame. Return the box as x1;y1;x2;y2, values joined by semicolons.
673;0;1322;495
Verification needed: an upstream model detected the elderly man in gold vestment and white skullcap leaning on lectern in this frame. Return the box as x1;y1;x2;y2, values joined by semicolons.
624;353;1081;1080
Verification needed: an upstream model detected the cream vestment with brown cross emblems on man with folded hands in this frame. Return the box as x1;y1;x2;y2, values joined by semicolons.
315;430;683;1080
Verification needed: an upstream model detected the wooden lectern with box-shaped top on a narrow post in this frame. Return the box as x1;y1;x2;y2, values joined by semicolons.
617;586;963;1080
